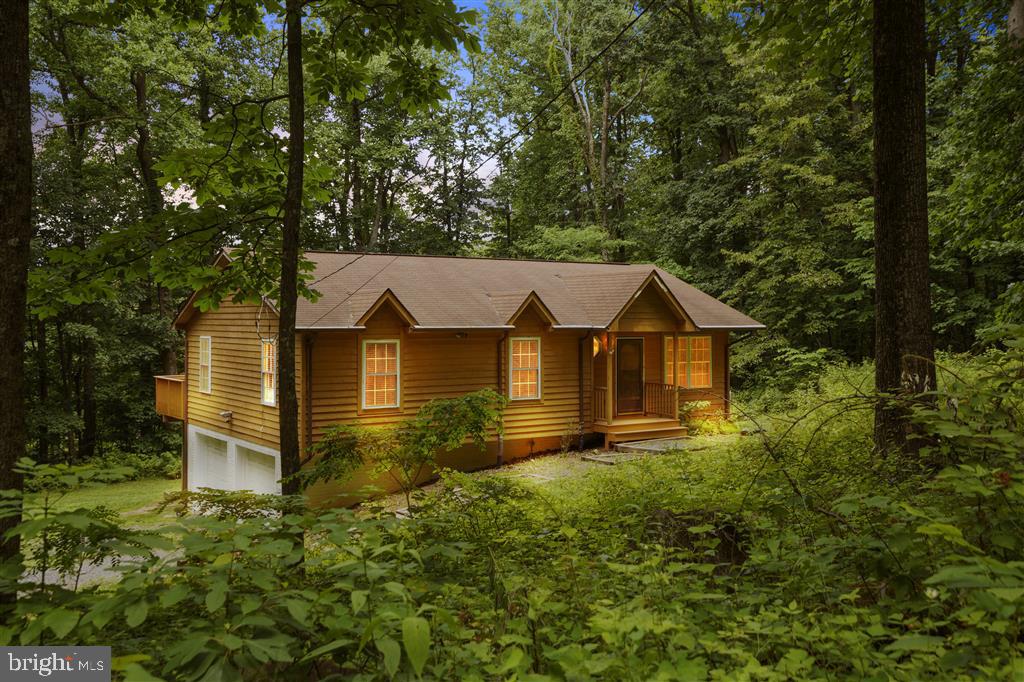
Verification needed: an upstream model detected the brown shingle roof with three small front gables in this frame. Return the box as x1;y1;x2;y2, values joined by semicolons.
296;251;764;329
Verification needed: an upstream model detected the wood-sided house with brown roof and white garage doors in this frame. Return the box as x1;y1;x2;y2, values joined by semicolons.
156;252;763;499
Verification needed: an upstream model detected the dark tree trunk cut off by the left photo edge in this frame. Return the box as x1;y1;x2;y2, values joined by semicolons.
0;0;32;604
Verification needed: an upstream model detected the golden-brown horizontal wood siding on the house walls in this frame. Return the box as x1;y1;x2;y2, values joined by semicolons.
180;287;728;501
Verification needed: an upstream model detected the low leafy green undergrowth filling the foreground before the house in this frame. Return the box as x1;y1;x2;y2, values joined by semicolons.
0;327;1024;680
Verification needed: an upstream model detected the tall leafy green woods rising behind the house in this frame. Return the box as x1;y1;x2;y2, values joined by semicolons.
14;0;1024;461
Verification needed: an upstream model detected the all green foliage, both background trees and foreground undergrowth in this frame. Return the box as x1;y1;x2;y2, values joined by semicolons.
14;0;1024;680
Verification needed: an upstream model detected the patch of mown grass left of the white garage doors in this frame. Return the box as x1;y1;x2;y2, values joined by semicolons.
27;478;181;526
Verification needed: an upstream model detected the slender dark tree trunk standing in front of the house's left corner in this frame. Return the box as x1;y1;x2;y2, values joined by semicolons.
278;0;306;495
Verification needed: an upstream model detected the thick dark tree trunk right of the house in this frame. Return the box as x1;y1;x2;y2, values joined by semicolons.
871;0;935;452
